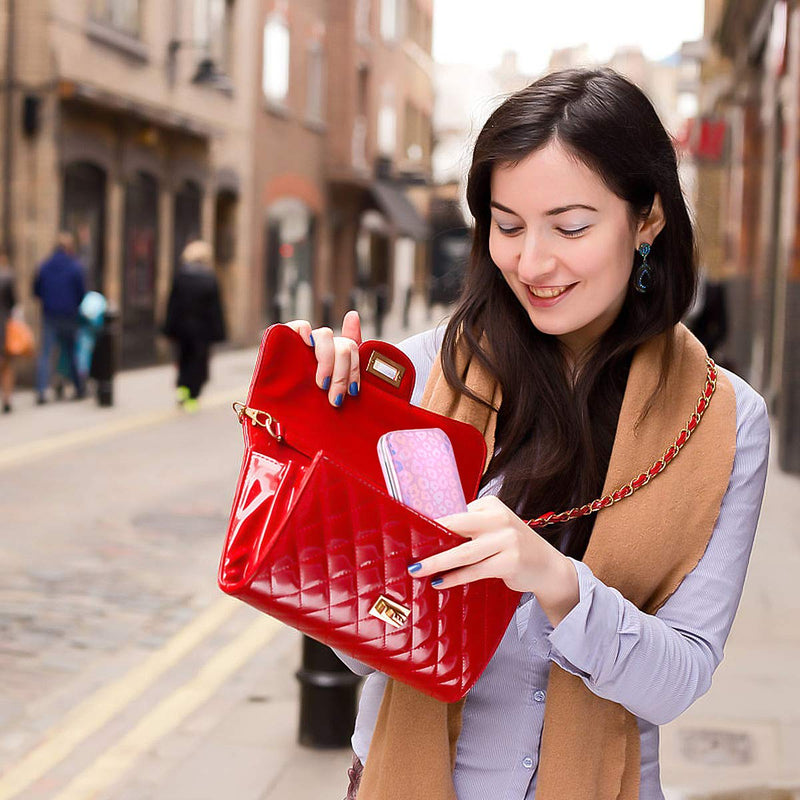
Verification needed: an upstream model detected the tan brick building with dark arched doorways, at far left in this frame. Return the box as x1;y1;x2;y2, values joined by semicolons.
0;0;257;366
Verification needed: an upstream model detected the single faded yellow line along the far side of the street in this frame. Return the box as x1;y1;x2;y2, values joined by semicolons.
0;386;247;469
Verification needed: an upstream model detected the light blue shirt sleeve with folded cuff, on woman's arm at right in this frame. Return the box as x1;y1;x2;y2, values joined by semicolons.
549;376;769;725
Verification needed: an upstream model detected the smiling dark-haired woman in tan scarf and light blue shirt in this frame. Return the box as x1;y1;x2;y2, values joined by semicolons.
291;69;769;800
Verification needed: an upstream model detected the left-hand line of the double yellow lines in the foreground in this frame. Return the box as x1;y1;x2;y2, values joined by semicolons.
0;597;241;800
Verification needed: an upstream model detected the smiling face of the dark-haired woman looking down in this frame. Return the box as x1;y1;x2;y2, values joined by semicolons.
489;142;646;355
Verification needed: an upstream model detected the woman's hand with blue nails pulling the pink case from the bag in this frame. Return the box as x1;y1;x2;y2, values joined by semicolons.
409;496;580;627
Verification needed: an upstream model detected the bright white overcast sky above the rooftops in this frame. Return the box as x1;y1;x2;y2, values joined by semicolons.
433;0;704;74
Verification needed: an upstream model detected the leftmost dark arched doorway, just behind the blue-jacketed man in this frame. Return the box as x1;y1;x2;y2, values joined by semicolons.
61;161;106;292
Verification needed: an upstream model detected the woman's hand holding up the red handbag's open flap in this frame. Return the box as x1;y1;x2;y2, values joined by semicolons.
286;311;361;408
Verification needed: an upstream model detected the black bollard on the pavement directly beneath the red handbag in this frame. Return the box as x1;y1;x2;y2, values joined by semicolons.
296;636;361;750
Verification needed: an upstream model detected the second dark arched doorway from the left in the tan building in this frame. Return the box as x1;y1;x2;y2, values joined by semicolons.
122;172;158;366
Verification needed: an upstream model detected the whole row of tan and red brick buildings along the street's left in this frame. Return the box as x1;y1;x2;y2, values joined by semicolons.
0;0;434;366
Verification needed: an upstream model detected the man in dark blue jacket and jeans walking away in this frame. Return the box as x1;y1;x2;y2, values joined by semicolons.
33;231;86;405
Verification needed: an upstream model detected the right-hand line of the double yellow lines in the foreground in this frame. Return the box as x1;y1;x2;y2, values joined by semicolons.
50;616;283;800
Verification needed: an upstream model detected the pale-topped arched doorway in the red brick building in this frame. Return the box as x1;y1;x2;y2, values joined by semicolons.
264;198;316;323
